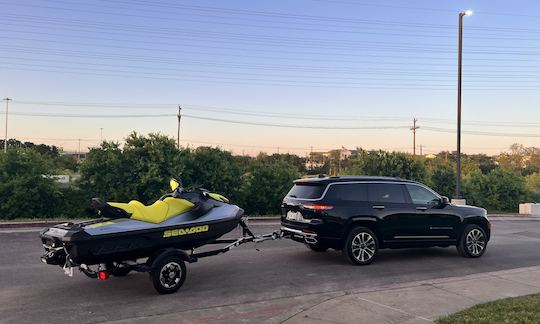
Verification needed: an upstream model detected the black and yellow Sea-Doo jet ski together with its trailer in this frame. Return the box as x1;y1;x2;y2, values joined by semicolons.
40;179;282;294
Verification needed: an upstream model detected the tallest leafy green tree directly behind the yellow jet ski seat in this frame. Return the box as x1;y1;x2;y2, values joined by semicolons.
81;133;189;203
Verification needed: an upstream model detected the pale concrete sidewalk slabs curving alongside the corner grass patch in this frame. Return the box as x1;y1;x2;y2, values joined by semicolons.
284;266;540;324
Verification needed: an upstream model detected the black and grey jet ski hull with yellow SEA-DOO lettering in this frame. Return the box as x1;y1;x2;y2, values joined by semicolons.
41;204;243;266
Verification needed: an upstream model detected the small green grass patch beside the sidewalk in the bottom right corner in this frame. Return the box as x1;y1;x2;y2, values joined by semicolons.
437;294;540;324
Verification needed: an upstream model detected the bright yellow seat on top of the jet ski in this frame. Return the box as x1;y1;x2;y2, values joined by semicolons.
109;197;195;224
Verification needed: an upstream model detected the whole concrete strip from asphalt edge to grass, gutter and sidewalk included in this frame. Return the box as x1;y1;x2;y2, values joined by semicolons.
107;266;540;324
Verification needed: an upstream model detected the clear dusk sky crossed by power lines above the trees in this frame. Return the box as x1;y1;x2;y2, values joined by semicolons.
0;0;540;155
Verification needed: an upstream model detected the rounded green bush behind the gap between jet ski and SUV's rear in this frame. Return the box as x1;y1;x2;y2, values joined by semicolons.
241;158;300;215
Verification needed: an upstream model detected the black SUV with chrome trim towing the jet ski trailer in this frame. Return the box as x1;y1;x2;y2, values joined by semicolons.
281;176;491;265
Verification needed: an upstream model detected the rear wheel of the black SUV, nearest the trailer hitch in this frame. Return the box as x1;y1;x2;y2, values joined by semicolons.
343;226;379;265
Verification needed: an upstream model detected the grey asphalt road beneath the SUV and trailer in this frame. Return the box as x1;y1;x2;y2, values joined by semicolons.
0;221;540;323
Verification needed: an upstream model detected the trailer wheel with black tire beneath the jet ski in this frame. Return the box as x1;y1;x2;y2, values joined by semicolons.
150;255;186;294
